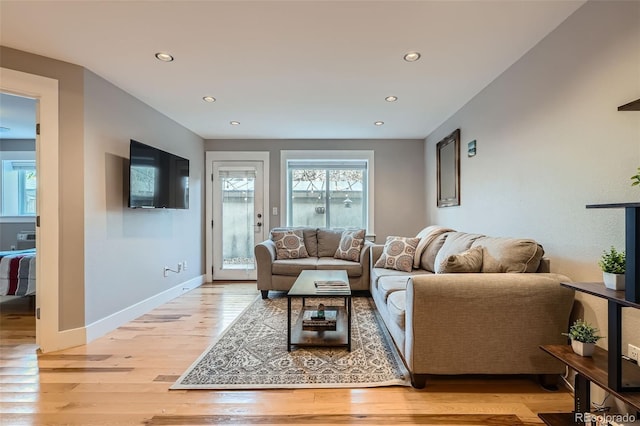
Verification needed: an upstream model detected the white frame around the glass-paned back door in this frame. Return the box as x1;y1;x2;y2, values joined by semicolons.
205;151;271;282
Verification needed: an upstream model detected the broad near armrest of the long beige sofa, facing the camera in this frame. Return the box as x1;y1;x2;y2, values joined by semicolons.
404;273;574;374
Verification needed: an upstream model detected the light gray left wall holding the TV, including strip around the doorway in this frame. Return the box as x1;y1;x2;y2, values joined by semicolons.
0;46;204;330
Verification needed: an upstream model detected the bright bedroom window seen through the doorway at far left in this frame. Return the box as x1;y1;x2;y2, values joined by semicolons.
0;160;36;216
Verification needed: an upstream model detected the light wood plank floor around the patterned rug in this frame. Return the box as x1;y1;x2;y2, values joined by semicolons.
0;284;573;426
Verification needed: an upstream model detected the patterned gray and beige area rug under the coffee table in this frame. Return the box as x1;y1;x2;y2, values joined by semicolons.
171;297;411;389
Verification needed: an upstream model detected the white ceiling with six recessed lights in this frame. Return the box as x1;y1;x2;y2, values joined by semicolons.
0;0;584;139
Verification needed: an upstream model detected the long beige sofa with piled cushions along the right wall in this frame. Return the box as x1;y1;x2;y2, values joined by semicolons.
370;226;574;388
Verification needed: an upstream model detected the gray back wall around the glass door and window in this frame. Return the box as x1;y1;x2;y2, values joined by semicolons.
205;139;426;243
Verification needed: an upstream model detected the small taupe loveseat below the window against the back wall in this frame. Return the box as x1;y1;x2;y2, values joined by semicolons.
254;228;373;299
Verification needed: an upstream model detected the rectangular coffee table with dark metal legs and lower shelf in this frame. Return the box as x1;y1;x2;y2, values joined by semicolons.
287;270;352;351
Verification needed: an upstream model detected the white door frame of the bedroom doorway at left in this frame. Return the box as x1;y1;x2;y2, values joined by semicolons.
0;68;62;352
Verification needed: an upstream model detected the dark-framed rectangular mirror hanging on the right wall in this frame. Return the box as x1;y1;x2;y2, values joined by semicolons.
436;129;460;207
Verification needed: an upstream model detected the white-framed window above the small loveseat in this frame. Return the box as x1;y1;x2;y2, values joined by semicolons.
282;151;373;231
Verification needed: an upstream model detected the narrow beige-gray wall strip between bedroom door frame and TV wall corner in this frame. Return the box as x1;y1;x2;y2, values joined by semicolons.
0;46;85;330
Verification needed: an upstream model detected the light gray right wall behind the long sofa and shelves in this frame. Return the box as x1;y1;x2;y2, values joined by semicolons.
426;1;640;364
